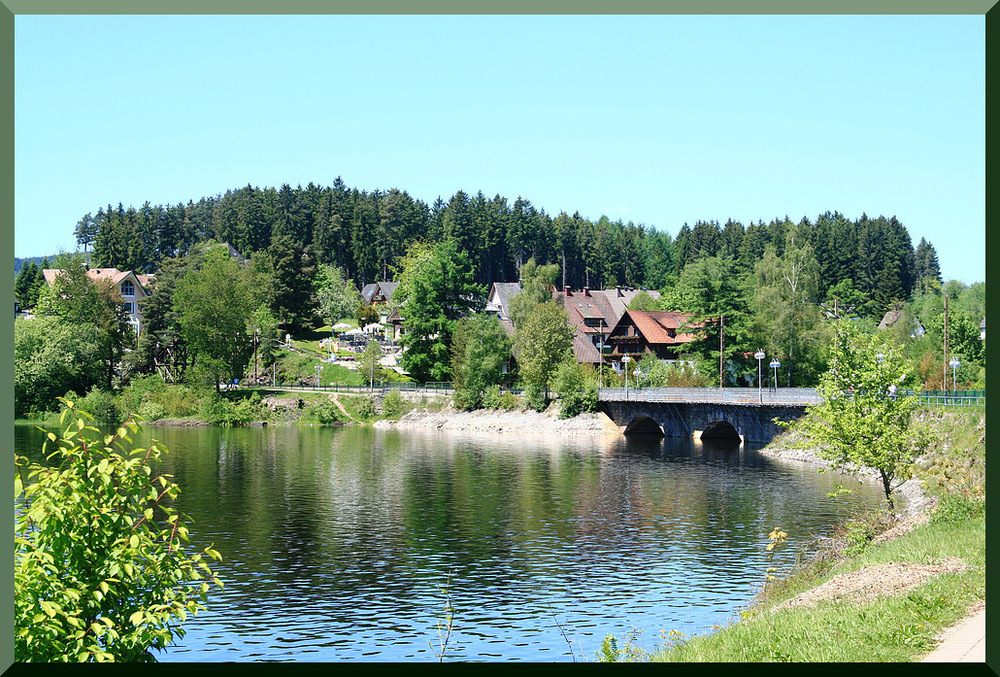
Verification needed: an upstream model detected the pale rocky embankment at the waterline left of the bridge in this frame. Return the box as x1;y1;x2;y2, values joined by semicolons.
375;409;621;435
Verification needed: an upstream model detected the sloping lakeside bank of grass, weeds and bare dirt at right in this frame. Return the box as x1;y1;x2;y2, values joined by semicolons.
624;410;986;662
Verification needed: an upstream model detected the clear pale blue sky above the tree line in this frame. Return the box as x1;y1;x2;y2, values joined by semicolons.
15;15;986;284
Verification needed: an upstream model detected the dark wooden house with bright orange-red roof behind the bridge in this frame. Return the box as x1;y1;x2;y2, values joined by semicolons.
607;310;697;362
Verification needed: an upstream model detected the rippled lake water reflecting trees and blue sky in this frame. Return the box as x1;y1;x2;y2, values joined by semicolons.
15;426;881;662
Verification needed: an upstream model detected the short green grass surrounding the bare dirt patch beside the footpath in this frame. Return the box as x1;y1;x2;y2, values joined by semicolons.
652;519;986;662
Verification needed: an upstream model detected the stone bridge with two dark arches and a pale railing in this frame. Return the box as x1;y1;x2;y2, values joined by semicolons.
599;388;819;443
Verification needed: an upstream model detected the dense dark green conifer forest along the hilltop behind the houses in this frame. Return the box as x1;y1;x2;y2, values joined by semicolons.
75;178;940;316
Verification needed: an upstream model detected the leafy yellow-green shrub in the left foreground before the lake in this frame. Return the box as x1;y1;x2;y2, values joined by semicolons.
14;400;222;662
